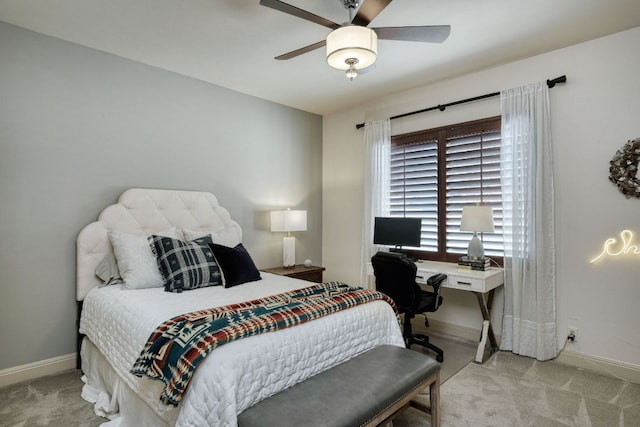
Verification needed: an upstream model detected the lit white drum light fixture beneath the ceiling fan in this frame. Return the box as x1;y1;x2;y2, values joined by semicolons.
327;25;378;72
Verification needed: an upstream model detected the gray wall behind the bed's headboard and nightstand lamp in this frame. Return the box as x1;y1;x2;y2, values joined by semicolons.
0;22;322;369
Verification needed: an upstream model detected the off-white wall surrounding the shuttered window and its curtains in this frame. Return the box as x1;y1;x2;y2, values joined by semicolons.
323;28;640;368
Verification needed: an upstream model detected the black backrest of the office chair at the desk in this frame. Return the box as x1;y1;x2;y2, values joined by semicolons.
371;252;420;312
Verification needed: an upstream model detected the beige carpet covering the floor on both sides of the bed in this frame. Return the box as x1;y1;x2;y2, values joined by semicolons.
0;336;640;427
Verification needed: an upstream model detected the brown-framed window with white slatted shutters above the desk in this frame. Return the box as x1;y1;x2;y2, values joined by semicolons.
389;117;504;262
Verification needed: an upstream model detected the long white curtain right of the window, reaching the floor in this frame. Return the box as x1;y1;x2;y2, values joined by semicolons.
500;82;557;360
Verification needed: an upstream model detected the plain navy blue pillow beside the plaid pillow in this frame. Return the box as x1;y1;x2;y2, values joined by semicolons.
209;243;262;288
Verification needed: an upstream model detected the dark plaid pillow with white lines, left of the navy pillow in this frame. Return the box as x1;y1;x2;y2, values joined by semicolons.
149;235;222;292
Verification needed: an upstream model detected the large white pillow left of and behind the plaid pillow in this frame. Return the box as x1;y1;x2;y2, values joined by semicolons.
108;228;180;289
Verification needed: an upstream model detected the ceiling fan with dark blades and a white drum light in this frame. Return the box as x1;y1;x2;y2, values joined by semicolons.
260;0;451;80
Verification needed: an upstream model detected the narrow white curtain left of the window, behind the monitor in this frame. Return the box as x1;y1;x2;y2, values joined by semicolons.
360;119;391;287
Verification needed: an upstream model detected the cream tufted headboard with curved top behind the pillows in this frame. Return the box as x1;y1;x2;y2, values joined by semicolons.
76;188;242;301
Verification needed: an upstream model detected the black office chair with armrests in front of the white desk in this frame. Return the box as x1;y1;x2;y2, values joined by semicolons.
371;252;447;362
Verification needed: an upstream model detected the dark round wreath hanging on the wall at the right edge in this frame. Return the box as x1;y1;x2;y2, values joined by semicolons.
609;138;640;199
